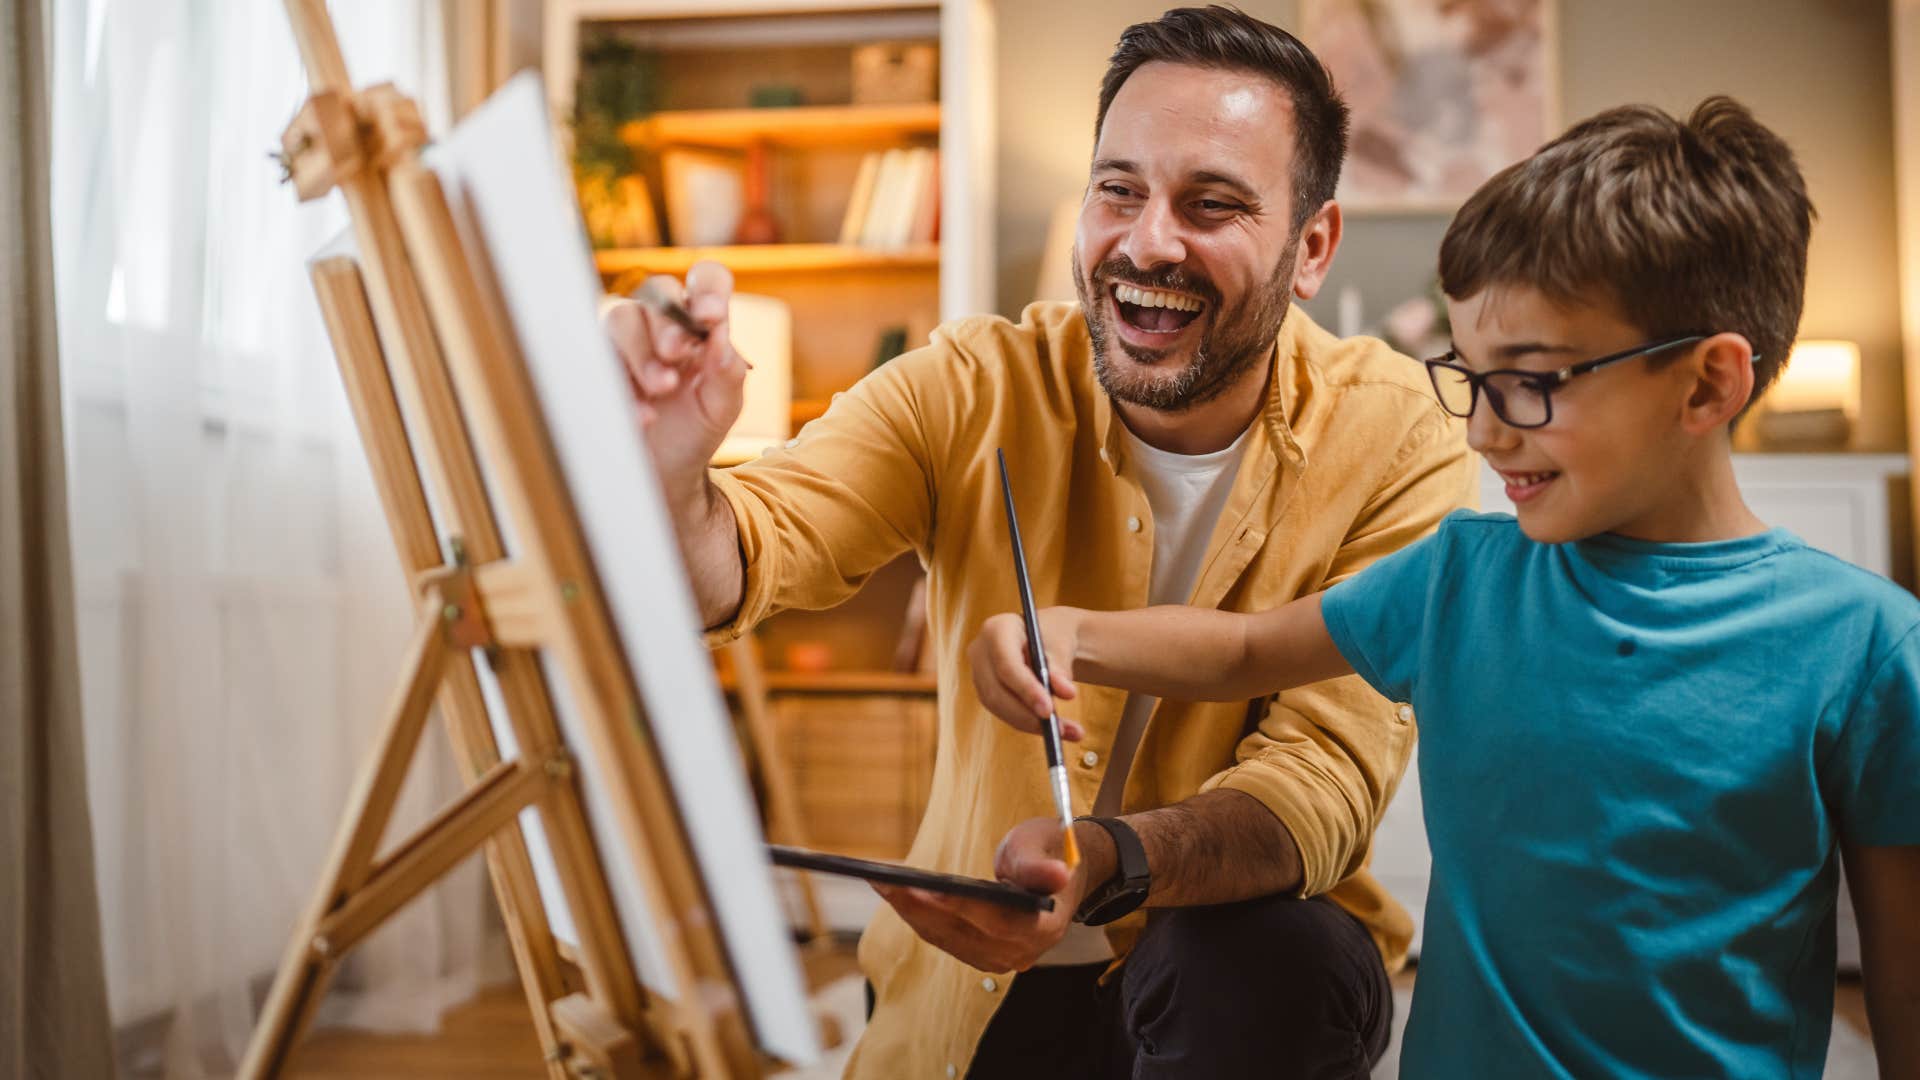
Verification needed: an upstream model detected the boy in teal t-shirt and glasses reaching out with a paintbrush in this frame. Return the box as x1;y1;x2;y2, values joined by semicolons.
972;98;1920;1076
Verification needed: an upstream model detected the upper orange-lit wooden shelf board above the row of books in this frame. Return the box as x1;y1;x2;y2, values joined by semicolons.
620;102;941;150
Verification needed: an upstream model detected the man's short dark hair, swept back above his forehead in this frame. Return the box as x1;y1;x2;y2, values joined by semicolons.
1092;4;1346;229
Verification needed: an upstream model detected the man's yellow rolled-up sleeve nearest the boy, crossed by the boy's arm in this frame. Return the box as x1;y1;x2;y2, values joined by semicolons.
1202;409;1476;896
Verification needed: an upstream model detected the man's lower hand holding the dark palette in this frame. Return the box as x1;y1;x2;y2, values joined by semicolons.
874;817;1114;970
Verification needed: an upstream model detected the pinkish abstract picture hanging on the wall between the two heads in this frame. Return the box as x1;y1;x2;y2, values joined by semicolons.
1300;0;1559;211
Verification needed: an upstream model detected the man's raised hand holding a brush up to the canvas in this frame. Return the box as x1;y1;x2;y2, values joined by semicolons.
601;263;749;515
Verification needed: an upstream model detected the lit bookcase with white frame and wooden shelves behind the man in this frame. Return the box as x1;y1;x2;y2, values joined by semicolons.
543;0;995;883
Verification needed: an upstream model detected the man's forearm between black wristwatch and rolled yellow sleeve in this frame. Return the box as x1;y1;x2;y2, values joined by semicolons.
1125;788;1300;907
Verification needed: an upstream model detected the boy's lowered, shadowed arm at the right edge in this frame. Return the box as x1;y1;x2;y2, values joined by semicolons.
1843;844;1920;1076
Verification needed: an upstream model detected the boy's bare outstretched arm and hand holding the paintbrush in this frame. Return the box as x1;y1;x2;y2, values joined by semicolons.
972;594;1354;726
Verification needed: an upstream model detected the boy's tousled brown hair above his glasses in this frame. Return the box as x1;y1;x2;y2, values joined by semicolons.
1440;96;1812;405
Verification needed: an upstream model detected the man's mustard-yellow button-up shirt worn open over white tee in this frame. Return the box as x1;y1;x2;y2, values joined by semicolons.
712;304;1473;1078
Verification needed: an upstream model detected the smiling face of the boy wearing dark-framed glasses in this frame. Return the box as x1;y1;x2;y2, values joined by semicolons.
1448;286;1697;544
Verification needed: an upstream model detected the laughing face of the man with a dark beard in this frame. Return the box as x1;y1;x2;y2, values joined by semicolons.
1073;63;1298;411
